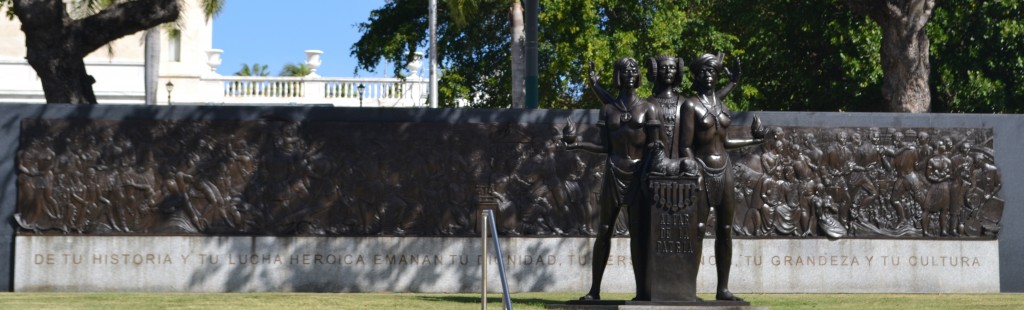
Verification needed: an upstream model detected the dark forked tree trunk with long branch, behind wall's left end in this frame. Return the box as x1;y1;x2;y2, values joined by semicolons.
13;0;179;103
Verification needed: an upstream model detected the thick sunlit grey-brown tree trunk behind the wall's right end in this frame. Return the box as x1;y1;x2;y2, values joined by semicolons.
846;0;935;113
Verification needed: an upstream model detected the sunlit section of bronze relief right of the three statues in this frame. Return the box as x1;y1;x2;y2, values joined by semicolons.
731;127;1004;238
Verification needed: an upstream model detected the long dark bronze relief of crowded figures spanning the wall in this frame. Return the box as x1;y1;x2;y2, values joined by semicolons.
14;119;1004;238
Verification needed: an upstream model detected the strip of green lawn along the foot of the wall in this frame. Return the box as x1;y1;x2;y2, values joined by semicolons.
0;293;1024;310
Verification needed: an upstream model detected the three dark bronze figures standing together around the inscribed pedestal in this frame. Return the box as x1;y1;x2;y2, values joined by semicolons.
563;54;767;301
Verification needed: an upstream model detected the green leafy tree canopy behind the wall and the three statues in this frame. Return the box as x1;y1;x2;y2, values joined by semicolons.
351;0;1024;113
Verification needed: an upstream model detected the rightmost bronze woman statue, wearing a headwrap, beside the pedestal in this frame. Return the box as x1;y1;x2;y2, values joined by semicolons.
680;54;766;301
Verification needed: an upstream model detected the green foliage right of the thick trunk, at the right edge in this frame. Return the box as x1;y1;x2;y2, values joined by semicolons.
928;0;1024;113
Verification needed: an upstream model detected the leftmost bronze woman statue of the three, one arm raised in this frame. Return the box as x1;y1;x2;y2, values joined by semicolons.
563;57;657;300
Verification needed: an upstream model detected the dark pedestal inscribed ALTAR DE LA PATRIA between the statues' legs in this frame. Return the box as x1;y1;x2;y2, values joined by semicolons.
645;176;708;302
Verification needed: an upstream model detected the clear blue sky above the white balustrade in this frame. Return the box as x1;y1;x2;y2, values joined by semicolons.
213;0;392;78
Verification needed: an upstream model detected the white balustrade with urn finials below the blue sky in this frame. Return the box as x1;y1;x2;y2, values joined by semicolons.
200;76;428;107
